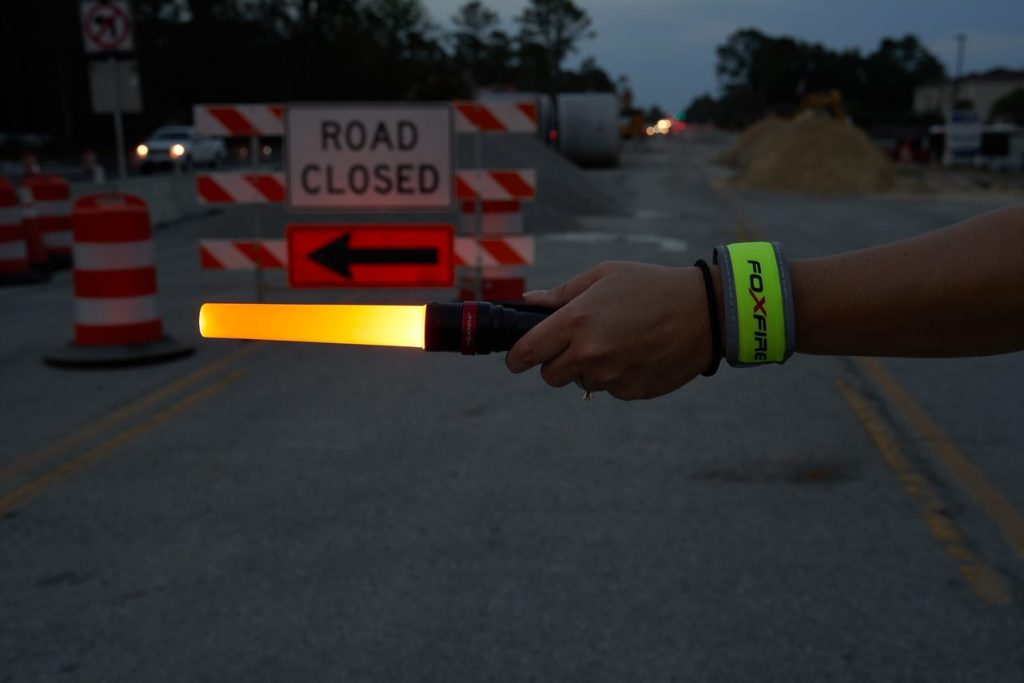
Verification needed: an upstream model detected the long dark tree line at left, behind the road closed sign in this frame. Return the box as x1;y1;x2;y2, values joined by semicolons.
0;0;614;156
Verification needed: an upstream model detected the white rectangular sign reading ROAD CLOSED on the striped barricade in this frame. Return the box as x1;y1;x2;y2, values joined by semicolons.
285;105;453;210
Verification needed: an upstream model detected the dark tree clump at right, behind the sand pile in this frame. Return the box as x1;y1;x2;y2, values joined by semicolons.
686;29;946;128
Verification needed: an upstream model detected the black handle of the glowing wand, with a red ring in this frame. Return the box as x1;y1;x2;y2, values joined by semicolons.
424;301;553;355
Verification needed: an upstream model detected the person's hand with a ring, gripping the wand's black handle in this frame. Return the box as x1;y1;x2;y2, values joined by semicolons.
505;262;712;400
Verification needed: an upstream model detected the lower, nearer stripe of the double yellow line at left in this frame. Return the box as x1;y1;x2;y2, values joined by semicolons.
0;370;245;518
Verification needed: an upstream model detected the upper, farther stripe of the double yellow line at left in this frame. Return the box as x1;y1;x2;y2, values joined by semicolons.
0;343;263;482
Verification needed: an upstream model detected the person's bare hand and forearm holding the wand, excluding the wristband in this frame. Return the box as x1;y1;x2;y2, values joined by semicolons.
506;207;1024;399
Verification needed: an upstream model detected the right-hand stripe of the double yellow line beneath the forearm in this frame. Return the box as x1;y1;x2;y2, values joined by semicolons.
857;358;1024;557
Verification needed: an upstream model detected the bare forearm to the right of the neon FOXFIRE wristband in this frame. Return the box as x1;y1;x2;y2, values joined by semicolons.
791;207;1024;356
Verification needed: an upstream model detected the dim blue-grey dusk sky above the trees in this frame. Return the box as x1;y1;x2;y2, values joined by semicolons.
424;0;1024;111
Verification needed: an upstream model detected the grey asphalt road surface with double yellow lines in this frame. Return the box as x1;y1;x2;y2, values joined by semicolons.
0;131;1024;683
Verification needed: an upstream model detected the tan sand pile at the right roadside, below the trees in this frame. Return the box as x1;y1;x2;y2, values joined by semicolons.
719;114;894;195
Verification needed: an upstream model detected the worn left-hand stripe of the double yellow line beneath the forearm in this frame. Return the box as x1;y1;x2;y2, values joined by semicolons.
836;379;1012;605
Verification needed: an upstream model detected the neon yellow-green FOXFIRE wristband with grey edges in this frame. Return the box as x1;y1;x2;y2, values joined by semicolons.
715;242;797;368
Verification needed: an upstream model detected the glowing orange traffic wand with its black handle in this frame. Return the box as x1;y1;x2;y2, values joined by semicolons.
199;301;551;355
